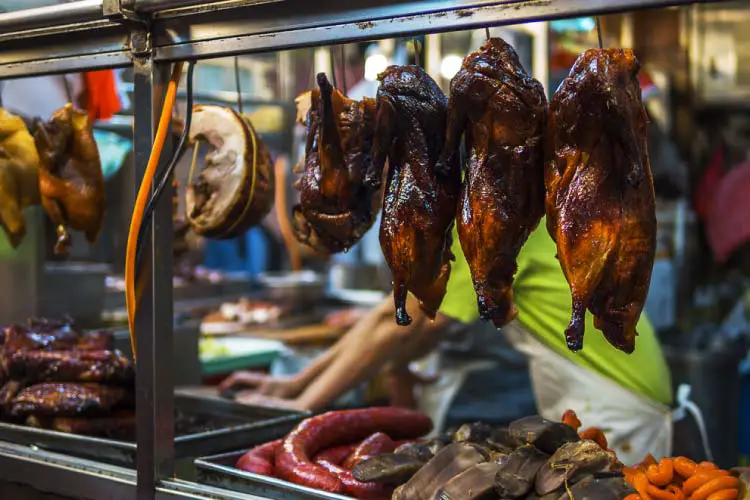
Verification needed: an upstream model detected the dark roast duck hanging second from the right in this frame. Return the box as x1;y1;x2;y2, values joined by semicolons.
438;38;547;328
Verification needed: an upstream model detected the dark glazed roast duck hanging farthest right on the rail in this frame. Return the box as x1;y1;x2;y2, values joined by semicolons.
545;49;656;353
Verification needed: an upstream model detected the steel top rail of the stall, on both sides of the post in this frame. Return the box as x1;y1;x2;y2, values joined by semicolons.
0;0;717;78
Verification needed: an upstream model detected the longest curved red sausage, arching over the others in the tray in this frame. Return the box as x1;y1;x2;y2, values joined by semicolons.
275;408;432;493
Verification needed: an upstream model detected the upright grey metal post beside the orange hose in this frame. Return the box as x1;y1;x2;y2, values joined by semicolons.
133;33;174;500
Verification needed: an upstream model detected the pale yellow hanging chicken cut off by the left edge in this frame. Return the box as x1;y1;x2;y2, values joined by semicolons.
0;109;40;248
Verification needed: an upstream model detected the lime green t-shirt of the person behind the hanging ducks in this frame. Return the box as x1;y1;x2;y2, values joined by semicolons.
440;220;672;405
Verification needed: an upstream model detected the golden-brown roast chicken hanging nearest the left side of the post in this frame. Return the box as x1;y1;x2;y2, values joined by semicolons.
34;104;107;255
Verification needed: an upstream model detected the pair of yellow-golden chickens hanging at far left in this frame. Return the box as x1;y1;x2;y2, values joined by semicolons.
0;104;106;255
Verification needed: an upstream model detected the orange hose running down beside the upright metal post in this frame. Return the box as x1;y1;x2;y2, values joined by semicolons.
125;62;182;360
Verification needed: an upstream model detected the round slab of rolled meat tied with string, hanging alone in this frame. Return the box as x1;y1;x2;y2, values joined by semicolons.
185;104;274;239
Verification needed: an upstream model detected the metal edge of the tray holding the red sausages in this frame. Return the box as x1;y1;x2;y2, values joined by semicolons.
195;450;352;500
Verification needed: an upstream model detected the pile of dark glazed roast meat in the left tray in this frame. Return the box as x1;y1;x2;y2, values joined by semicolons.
0;320;135;435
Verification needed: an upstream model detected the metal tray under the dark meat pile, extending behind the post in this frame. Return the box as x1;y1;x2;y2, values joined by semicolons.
0;394;309;467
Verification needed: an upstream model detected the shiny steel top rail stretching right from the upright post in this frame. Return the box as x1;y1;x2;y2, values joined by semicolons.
155;0;694;61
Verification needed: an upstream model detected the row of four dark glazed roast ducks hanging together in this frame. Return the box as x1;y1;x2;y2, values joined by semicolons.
295;38;656;352
